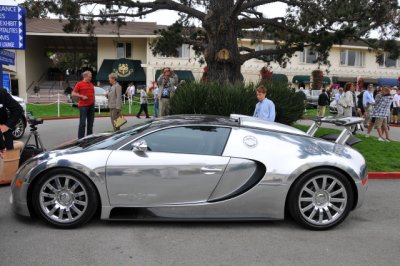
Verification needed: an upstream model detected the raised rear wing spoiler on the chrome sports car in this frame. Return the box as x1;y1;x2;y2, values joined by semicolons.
307;116;364;145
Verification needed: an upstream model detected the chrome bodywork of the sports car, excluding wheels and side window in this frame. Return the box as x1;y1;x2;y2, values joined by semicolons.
11;116;367;220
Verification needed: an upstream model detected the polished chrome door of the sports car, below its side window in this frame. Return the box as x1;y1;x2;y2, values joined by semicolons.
106;150;229;207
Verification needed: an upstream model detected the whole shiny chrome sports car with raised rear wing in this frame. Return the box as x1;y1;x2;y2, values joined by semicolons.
10;115;367;230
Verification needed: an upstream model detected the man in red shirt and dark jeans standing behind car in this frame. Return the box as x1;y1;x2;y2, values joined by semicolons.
72;71;94;139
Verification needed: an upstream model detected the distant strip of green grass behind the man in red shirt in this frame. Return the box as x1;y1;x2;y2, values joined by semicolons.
27;102;154;118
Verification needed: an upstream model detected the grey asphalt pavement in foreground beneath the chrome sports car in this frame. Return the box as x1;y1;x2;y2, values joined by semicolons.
0;180;400;266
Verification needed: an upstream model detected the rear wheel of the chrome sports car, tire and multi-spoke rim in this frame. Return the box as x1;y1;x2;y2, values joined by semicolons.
288;168;354;230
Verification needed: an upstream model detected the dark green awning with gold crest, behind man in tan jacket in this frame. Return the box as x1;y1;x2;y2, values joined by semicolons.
96;58;146;82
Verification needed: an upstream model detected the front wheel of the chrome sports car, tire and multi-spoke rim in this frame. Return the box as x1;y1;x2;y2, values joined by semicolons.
32;169;99;229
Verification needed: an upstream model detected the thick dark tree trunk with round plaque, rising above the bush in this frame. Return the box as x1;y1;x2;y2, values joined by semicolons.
203;0;243;83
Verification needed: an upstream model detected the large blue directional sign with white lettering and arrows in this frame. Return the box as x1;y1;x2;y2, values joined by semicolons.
0;5;26;49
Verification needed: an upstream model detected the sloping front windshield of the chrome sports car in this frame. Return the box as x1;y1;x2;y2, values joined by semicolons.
83;121;152;150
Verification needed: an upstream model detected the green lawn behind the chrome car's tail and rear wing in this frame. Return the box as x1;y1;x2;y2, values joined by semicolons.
295;125;400;172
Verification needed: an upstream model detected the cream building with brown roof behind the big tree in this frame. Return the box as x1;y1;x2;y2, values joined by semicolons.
4;19;400;98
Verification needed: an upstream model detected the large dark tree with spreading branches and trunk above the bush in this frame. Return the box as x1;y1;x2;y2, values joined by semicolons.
25;0;400;83
